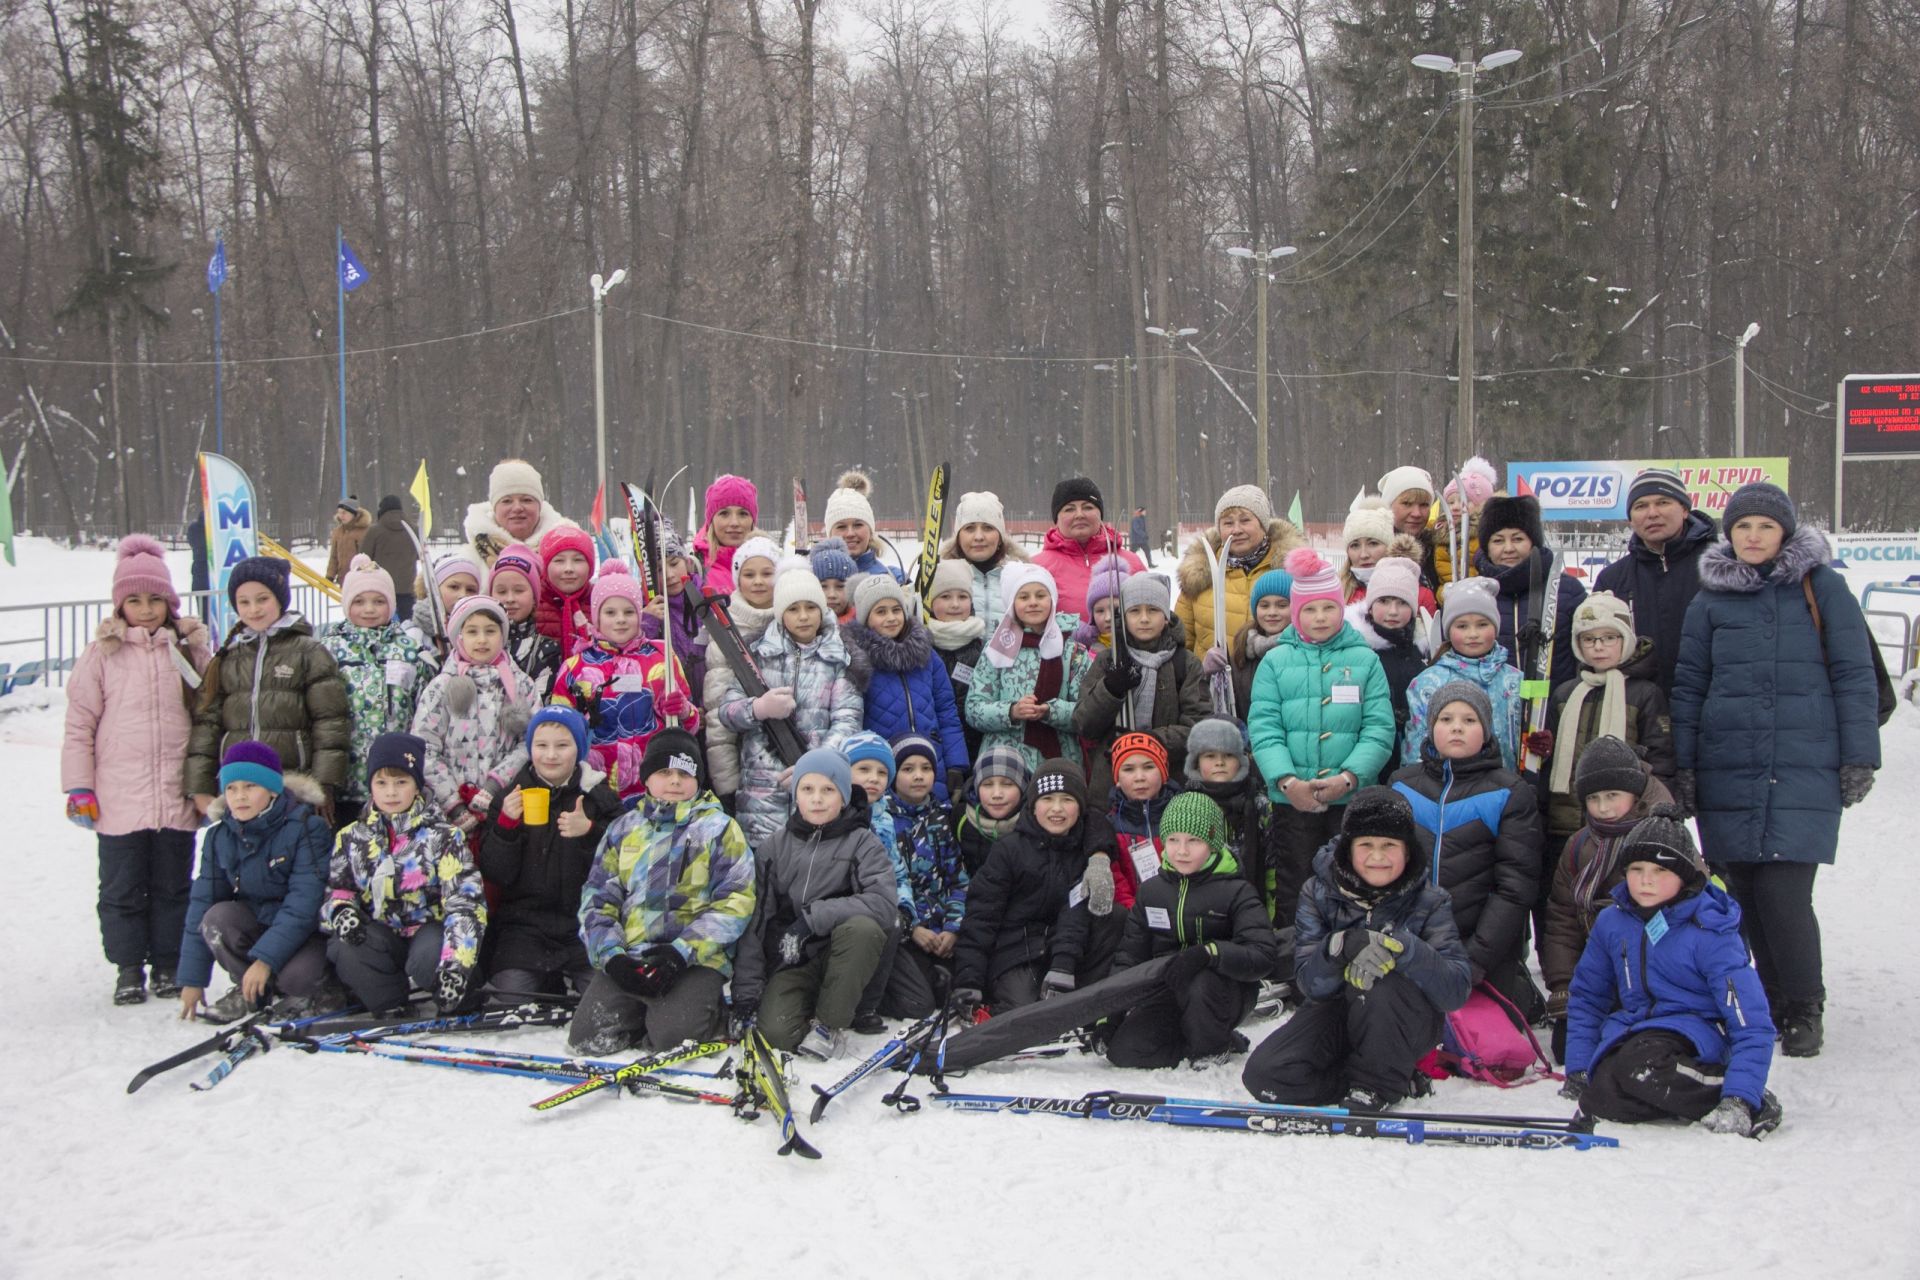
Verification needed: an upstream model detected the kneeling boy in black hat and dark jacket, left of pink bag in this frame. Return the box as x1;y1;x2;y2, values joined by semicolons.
1240;787;1473;1111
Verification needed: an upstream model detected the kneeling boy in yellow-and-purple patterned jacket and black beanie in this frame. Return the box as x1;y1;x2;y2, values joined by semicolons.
566;727;755;1055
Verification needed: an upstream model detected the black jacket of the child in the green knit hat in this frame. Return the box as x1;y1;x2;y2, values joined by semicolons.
1114;852;1281;983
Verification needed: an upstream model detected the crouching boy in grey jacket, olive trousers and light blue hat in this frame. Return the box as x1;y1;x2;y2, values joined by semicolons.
733;748;900;1061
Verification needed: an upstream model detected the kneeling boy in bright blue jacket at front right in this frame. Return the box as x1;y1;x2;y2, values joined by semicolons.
1561;804;1780;1138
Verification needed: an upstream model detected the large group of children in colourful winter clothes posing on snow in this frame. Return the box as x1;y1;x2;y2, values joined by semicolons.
63;462;1778;1128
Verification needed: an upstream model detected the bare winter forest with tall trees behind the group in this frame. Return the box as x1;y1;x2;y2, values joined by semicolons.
0;0;1920;533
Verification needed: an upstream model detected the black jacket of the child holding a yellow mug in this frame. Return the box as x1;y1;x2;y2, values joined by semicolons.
478;764;622;973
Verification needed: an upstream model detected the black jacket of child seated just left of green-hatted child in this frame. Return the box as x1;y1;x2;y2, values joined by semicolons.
954;806;1117;990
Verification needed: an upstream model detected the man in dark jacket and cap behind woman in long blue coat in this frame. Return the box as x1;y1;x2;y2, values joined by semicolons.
1594;466;1720;695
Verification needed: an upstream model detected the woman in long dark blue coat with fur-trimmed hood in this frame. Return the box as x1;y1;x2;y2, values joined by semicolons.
1672;484;1880;1057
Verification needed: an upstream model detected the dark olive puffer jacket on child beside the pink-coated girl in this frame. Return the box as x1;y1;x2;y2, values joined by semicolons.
186;614;353;796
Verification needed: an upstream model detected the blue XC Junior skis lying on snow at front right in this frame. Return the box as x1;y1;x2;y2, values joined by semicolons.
939;1092;1620;1151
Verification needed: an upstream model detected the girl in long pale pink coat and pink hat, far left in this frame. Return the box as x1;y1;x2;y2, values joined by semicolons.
60;533;211;1004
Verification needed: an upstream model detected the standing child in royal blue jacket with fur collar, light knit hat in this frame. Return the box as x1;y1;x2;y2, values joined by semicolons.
841;574;968;804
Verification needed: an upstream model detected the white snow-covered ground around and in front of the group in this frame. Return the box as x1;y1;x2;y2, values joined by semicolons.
0;543;1920;1276
